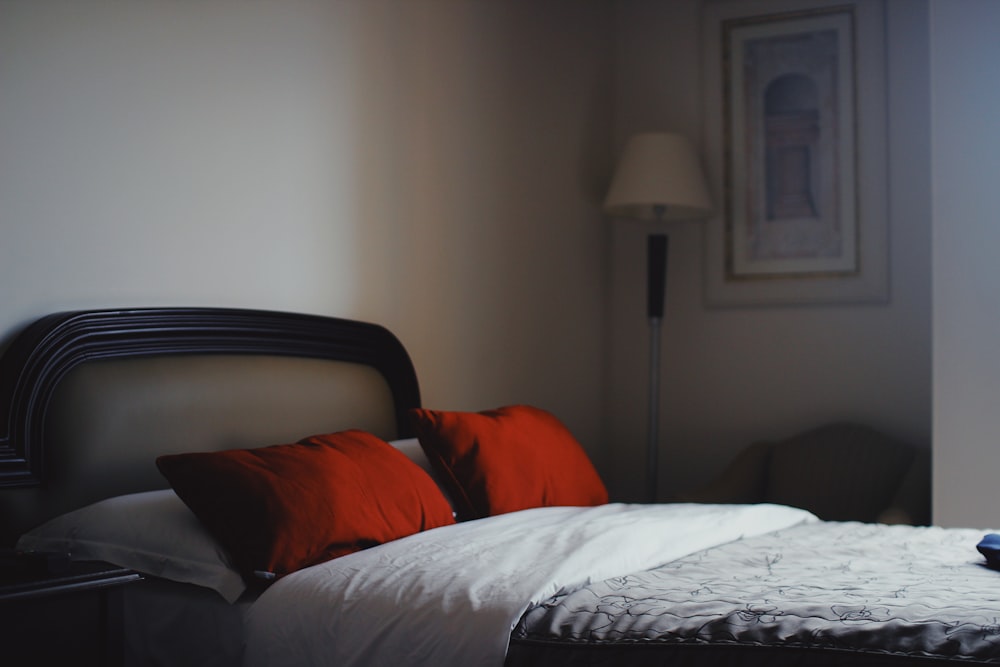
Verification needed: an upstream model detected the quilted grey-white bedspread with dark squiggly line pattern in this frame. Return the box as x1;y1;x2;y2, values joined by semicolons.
509;522;1000;664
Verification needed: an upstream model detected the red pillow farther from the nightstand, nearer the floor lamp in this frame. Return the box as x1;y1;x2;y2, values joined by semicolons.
410;405;608;520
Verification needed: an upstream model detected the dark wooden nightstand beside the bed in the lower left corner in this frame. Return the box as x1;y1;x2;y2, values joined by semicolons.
0;560;142;667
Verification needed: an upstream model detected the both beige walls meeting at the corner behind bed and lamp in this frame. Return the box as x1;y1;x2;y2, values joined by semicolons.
0;0;948;512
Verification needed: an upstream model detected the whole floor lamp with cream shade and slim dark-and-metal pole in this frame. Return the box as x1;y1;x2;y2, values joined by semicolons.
604;133;712;502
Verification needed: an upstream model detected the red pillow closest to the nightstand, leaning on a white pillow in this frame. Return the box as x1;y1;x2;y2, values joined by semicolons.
156;430;455;578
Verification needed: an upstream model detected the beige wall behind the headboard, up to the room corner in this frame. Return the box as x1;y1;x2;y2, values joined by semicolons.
0;0;611;450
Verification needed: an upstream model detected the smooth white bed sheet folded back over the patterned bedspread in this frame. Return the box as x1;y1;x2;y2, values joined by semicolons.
244;504;817;667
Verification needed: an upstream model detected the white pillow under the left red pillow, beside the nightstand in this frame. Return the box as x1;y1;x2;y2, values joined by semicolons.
17;489;246;602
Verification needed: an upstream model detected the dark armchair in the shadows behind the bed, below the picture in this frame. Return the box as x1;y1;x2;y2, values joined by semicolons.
678;423;930;525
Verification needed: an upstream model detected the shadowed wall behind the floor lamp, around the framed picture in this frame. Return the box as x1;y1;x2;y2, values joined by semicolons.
606;0;931;498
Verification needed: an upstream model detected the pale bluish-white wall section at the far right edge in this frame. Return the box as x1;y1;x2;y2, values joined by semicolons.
930;0;1000;528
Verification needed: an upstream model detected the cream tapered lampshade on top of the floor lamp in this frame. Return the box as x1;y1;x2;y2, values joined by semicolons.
604;132;712;220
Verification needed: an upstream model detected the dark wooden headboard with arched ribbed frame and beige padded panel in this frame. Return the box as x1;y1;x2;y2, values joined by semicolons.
0;308;420;544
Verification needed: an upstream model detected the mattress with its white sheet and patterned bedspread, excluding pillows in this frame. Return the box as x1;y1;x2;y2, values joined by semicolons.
43;504;1000;667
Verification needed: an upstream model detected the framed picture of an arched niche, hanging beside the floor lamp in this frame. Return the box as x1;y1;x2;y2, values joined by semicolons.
704;0;888;306
